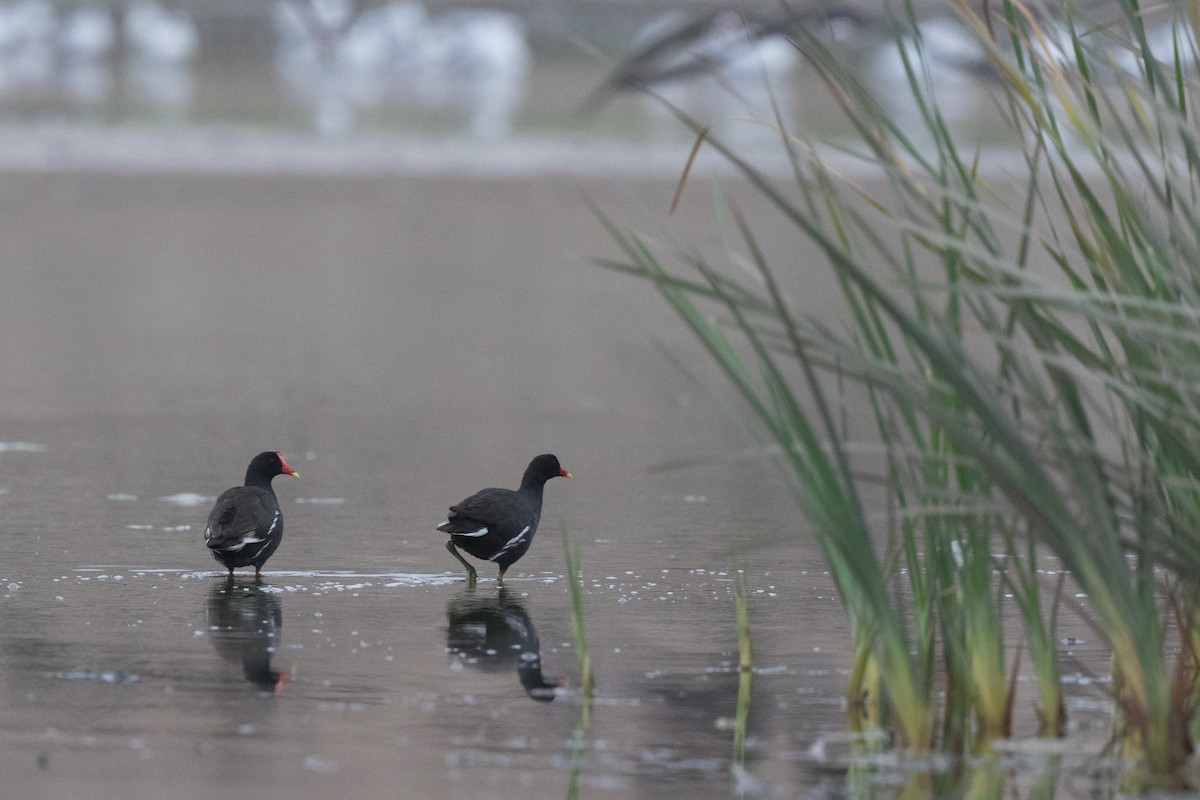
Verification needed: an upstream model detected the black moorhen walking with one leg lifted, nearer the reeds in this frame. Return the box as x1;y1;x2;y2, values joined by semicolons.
438;453;571;585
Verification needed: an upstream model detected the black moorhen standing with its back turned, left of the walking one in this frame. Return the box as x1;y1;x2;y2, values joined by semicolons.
204;450;300;577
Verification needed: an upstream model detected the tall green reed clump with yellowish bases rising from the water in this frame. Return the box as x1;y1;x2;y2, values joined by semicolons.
600;0;1200;786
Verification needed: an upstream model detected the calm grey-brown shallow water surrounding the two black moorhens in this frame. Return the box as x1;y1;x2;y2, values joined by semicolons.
0;21;1123;799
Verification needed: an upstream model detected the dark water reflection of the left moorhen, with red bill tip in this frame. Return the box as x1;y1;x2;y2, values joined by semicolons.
204;577;292;693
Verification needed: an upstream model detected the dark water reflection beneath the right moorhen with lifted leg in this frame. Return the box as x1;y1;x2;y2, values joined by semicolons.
446;587;562;703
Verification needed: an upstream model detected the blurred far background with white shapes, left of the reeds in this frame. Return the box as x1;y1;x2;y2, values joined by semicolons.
0;0;825;139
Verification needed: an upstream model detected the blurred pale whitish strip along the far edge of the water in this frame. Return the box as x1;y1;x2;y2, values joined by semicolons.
0;121;787;179
